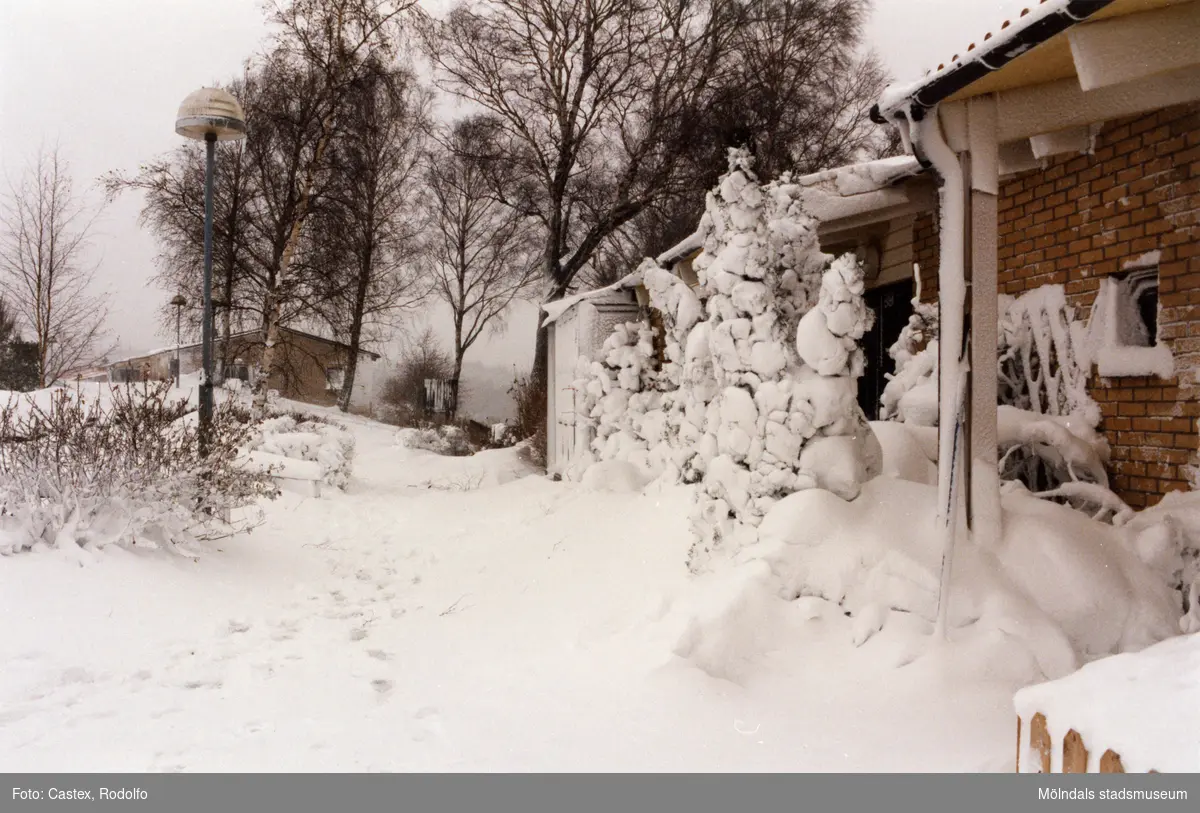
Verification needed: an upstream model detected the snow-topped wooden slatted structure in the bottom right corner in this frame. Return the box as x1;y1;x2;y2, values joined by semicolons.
1015;633;1200;773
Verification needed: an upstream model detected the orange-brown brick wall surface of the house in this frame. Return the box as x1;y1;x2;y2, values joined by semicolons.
913;106;1200;507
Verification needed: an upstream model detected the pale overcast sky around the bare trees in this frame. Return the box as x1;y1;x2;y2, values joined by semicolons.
0;0;1034;367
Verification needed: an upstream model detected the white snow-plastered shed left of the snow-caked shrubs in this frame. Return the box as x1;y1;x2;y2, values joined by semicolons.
542;275;641;474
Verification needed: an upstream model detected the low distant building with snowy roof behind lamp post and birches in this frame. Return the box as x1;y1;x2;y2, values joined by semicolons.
98;327;379;410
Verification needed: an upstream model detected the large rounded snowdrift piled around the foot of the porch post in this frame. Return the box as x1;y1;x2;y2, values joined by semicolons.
676;477;1180;682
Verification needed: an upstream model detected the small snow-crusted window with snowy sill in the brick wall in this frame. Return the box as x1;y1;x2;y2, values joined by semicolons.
1087;252;1175;378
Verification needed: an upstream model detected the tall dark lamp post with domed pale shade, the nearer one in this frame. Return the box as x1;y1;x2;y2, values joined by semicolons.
175;88;246;453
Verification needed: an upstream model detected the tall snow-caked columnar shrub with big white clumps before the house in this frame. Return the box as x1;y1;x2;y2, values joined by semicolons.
685;150;880;567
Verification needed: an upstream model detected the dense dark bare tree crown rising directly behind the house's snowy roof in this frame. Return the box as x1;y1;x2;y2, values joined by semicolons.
584;0;896;285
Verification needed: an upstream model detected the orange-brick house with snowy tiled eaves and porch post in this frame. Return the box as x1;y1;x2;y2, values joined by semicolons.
864;0;1200;516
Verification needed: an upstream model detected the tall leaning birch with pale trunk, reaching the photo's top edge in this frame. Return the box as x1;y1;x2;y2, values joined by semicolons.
247;0;415;409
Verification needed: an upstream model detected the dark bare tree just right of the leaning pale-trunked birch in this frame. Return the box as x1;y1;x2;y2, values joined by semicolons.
307;61;431;411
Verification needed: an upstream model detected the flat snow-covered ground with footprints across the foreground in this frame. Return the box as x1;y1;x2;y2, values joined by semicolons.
0;422;1014;771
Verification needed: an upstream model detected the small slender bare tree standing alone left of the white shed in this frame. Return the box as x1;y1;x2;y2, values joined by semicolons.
426;116;541;416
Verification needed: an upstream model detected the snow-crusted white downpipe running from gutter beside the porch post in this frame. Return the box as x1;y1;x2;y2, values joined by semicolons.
908;108;968;639
